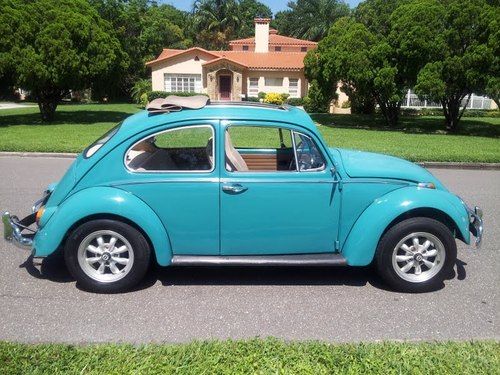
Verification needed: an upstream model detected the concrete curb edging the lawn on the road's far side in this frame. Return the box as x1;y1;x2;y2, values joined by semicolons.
0;152;500;170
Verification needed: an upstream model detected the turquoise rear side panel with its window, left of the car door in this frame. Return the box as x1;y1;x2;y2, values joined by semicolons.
121;122;220;255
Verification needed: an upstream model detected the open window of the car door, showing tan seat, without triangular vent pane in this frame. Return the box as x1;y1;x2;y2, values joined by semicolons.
224;126;297;172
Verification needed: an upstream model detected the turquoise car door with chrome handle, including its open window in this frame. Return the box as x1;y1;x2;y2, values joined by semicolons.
219;124;340;255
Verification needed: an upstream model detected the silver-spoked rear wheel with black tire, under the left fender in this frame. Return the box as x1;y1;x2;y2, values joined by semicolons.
64;220;150;293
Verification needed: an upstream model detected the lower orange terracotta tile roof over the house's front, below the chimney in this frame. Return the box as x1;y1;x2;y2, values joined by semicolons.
146;47;306;70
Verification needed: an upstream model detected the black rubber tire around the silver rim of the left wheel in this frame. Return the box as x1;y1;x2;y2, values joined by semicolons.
64;219;151;293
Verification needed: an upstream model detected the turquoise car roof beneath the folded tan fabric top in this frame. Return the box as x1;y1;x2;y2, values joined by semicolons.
119;102;317;137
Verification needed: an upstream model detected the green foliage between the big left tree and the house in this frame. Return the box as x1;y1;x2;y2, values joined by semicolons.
90;0;192;99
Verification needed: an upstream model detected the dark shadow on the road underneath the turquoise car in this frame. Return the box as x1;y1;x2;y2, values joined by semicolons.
19;254;467;291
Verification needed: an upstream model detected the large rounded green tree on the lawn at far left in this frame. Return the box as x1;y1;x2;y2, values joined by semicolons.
0;0;126;121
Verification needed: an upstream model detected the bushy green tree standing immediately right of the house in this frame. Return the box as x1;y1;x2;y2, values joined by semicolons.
305;0;410;126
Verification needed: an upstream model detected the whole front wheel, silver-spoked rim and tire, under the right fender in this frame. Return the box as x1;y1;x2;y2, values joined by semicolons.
375;217;457;293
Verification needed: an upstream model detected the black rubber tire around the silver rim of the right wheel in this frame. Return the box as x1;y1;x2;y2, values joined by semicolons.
375;217;457;293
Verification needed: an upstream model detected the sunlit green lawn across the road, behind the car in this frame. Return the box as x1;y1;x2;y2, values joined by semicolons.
0;104;500;163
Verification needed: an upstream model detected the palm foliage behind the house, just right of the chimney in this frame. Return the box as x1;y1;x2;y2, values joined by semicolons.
275;0;350;41
